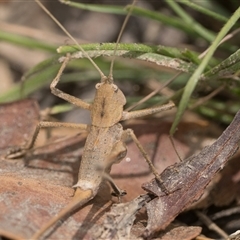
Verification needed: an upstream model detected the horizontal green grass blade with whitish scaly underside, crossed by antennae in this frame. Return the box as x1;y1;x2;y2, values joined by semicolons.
58;43;196;73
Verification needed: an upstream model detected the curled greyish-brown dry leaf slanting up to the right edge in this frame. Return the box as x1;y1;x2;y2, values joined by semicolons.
143;111;240;237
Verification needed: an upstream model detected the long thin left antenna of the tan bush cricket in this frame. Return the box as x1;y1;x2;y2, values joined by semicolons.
35;0;106;82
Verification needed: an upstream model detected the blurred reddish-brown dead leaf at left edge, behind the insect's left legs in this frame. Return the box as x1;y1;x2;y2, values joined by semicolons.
0;99;40;158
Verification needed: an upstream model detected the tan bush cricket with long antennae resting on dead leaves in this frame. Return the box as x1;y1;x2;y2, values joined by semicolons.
30;0;175;239
